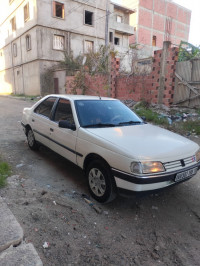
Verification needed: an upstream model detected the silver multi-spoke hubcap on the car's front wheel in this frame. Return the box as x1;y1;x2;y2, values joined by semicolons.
89;168;106;197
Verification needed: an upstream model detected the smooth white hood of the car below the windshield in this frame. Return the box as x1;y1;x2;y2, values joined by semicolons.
87;124;199;162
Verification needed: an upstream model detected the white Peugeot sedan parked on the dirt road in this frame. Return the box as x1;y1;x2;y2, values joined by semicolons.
22;95;200;202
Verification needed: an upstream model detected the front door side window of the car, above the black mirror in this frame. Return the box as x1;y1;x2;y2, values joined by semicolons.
54;99;74;124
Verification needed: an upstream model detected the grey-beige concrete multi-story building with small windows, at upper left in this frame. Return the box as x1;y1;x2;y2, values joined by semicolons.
0;0;133;95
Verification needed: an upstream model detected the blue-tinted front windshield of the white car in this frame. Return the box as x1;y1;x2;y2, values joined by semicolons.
75;100;144;128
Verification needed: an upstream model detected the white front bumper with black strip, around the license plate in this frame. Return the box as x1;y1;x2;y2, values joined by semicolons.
112;162;200;192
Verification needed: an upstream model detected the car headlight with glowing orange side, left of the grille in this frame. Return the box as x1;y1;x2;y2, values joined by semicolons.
130;162;165;174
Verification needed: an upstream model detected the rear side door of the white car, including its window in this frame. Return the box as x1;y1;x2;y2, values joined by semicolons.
31;97;57;147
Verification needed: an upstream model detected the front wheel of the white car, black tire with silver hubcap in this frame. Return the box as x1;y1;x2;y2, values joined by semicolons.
86;160;116;203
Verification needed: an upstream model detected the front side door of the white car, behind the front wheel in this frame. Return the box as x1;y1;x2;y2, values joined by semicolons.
47;98;77;163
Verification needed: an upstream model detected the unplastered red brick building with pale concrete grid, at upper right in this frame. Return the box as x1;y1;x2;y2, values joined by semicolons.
122;0;191;55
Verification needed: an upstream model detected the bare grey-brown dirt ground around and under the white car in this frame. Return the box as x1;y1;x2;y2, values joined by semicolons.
0;97;200;266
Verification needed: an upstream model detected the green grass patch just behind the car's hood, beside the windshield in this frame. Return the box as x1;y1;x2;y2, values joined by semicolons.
134;107;168;125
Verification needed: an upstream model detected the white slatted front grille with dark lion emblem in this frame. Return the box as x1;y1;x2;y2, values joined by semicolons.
164;156;196;171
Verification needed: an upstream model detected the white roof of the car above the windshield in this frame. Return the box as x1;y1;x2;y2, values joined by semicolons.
46;94;117;101
